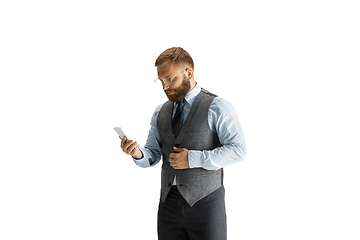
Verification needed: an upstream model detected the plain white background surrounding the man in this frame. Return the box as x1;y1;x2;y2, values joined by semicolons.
0;0;360;240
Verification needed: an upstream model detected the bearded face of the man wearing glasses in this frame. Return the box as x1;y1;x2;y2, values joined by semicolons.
157;62;190;102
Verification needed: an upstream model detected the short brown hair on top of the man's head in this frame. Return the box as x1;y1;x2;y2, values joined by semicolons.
155;47;194;69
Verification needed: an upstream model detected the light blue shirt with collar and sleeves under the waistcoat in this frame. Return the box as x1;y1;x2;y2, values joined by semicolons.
134;84;246;170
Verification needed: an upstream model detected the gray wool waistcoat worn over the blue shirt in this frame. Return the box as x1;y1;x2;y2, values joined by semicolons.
157;89;223;206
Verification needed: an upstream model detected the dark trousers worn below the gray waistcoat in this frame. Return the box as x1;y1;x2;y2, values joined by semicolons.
158;186;226;240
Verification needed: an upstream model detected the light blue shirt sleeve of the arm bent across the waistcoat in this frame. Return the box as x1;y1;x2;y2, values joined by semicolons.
188;97;246;170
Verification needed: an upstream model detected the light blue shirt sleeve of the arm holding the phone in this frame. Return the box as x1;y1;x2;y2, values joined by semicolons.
133;105;162;168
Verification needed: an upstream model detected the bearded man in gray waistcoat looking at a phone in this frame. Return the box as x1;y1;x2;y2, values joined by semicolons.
121;47;246;240
